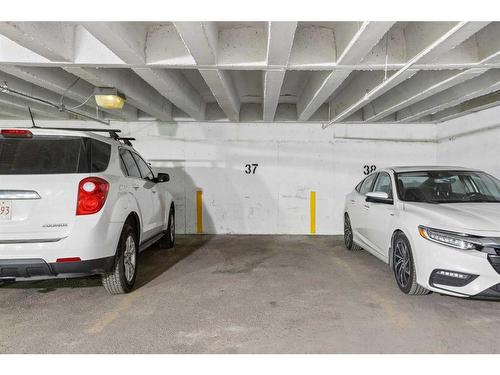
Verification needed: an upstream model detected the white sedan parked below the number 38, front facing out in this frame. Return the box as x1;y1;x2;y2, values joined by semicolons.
344;167;500;298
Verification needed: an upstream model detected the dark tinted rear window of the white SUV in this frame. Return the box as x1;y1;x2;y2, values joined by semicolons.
0;135;111;175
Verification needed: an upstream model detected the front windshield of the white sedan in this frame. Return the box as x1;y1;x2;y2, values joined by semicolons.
396;171;500;203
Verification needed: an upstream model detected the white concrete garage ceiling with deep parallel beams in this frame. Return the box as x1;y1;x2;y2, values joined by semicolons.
0;22;500;124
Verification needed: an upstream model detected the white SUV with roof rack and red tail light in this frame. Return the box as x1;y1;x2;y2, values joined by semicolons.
0;128;175;294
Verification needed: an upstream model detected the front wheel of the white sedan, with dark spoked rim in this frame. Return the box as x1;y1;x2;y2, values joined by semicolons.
392;232;430;295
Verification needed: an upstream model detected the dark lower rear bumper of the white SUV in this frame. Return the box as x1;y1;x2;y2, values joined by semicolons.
0;257;114;281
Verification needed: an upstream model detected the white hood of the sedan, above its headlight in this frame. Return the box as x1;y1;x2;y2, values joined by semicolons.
404;202;500;234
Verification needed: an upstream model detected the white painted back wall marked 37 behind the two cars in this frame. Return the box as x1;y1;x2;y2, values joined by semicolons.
0;121;444;234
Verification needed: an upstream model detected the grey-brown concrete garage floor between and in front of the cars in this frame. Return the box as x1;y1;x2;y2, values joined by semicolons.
0;236;500;353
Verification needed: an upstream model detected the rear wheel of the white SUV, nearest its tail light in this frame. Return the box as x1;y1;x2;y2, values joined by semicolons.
102;223;139;294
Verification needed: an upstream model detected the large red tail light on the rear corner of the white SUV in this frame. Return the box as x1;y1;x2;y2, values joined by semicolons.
76;177;109;215
